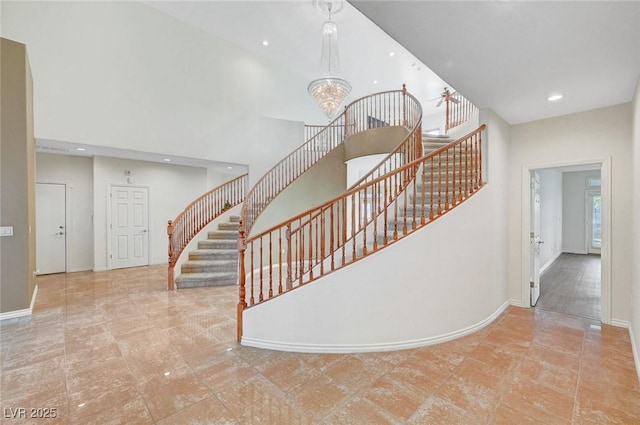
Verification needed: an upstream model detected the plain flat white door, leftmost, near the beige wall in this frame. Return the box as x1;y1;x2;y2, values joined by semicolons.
36;183;67;274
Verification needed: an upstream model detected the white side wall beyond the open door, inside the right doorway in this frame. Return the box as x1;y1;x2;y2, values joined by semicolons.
538;169;563;272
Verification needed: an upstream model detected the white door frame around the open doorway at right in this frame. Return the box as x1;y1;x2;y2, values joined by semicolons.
520;157;611;324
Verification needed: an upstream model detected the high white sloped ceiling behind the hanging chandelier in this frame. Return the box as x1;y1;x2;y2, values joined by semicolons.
144;0;456;113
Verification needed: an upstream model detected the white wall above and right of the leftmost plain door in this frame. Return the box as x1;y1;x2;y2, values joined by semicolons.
36;153;93;272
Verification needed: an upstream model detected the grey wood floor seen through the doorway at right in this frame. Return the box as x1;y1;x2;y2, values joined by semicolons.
536;253;601;320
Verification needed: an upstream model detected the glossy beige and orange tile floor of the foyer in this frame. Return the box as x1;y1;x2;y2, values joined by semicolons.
0;267;640;425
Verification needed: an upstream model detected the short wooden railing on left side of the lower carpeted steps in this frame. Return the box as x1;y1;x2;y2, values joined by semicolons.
167;174;248;290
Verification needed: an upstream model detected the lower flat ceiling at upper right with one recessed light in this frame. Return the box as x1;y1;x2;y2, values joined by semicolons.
353;0;640;124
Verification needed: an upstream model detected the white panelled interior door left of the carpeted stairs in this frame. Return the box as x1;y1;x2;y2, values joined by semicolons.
110;186;149;269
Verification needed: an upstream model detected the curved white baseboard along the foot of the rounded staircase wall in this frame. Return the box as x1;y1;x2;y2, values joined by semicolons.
241;301;511;353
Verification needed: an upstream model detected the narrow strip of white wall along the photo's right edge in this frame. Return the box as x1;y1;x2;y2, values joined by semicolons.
630;78;640;379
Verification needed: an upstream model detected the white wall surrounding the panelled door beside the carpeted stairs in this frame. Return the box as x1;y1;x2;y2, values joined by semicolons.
93;157;207;270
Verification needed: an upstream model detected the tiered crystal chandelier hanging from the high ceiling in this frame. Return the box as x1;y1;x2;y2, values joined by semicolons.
307;0;351;119
